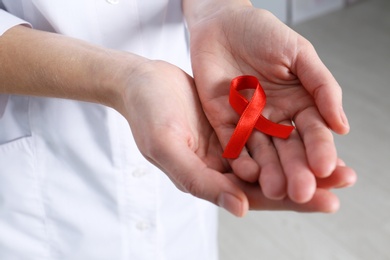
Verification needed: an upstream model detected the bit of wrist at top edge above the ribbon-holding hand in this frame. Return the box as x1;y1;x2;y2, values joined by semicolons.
183;0;252;28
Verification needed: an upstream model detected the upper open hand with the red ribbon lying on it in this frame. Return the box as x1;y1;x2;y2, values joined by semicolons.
187;1;354;203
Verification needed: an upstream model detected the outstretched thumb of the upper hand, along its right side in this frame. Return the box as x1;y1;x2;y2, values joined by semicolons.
294;41;349;134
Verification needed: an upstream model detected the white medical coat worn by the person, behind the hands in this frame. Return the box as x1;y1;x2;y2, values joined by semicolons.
0;0;217;260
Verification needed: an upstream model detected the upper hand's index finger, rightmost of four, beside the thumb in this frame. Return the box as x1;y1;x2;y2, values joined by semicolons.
294;107;337;178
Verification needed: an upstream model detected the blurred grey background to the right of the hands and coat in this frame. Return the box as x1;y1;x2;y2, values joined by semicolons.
219;0;390;260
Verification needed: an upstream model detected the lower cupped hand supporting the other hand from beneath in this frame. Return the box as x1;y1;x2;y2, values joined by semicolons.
119;61;354;216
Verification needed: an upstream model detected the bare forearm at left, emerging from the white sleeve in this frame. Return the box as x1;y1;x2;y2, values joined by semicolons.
0;26;143;111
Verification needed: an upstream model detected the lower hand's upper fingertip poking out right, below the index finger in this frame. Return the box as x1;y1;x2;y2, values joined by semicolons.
317;165;357;189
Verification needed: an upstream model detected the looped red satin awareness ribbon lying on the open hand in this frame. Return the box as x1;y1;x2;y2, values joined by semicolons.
222;76;294;159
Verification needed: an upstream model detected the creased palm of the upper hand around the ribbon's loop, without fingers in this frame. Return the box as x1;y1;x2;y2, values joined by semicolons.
191;9;314;123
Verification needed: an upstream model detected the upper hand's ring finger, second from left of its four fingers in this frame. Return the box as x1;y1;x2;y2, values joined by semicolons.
247;131;287;199
